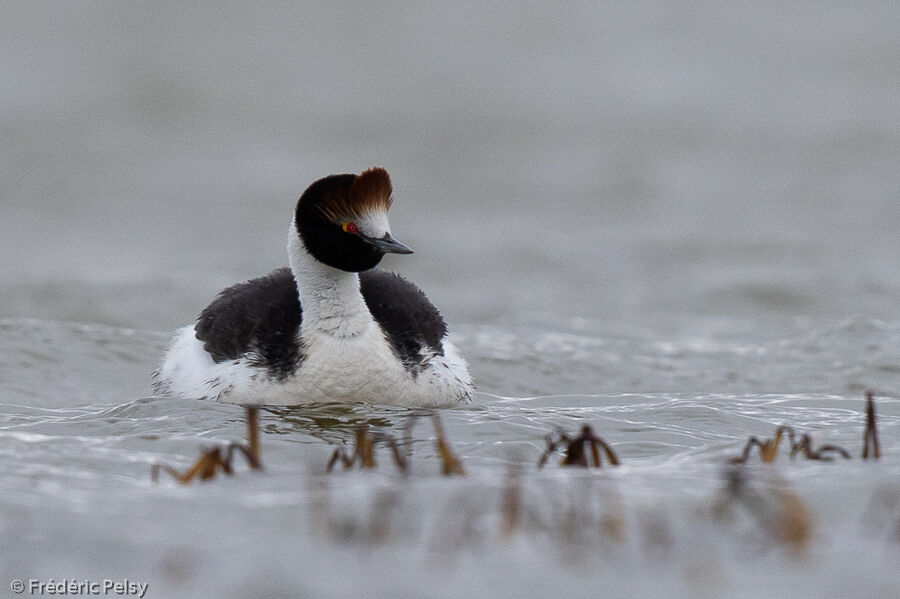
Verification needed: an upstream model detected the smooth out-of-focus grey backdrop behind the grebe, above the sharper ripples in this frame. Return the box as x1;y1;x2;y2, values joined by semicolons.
0;2;900;335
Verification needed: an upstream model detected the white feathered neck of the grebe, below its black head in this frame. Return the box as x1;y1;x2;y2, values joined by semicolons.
288;224;373;337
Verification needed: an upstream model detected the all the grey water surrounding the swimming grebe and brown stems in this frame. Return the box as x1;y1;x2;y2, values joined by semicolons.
0;2;900;597
